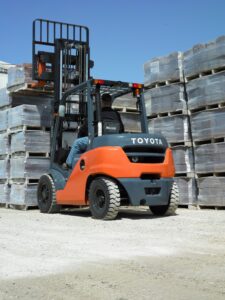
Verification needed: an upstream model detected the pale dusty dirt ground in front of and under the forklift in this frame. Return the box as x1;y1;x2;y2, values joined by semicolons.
0;208;225;300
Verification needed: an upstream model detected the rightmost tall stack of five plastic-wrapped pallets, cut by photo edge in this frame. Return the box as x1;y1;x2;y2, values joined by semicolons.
184;37;225;207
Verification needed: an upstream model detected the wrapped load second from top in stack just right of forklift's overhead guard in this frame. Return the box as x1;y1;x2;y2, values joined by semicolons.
144;84;187;116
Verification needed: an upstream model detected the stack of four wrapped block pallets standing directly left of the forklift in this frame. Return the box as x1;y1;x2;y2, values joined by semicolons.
8;104;50;207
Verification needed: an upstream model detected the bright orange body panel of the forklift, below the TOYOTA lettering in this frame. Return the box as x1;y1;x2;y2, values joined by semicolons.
56;146;175;205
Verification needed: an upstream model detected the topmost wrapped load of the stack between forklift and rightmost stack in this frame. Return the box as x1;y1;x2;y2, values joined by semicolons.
144;52;183;86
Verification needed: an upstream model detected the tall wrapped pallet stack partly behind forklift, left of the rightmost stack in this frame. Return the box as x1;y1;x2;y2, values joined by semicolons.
144;52;196;206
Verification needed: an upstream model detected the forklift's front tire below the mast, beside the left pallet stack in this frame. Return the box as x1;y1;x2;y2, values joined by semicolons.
37;174;61;214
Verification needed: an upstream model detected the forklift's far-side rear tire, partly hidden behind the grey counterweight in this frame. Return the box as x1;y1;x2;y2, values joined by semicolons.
149;182;179;216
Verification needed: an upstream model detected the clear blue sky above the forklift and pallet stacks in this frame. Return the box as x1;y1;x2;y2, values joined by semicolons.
0;0;225;82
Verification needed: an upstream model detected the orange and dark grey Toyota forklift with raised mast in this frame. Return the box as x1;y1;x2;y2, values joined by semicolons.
33;19;179;220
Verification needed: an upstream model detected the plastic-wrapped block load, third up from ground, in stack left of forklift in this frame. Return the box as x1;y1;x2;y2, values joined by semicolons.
10;130;50;153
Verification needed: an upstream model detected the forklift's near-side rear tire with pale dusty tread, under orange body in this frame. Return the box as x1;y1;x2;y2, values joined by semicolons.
88;177;120;220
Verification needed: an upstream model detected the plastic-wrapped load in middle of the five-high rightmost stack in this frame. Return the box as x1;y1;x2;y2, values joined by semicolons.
191;108;225;141
